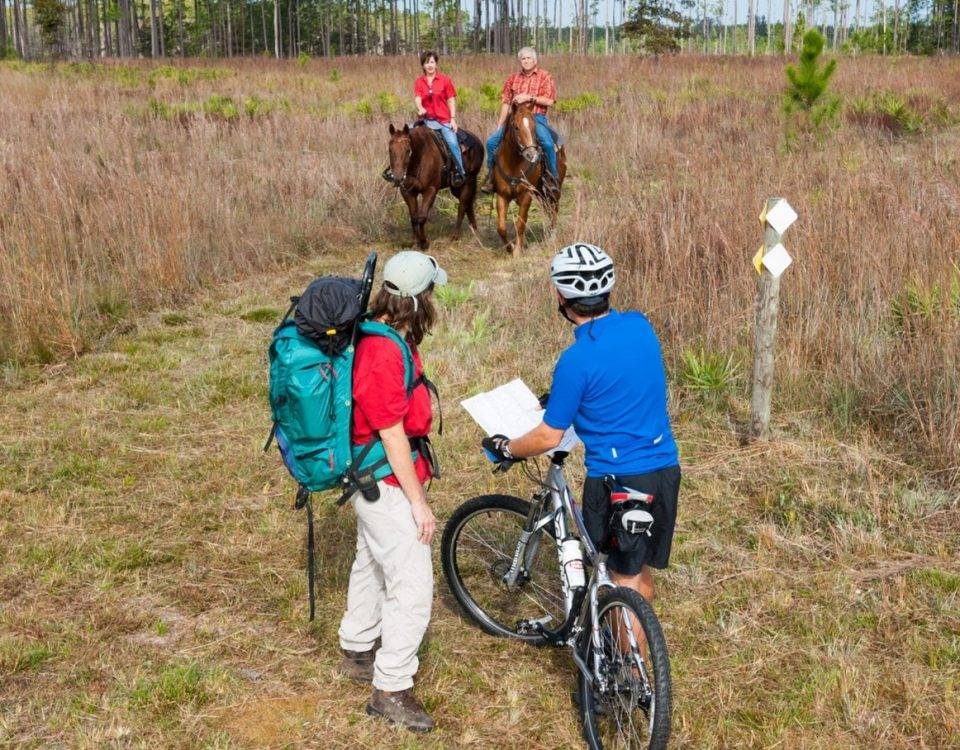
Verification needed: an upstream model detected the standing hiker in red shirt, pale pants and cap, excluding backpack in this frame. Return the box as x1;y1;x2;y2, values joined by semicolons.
339;250;447;732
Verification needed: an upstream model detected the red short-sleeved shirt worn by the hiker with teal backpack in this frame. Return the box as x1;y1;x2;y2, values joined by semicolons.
353;336;433;487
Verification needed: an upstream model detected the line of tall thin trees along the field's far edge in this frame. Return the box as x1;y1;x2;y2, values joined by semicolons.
0;0;960;59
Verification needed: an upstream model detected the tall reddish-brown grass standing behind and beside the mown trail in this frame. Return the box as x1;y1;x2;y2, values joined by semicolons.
0;57;960;478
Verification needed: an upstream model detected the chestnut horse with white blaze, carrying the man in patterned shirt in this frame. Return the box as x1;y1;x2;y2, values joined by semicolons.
493;104;567;254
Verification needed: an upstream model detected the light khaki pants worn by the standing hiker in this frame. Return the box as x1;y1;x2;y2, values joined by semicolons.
339;482;433;692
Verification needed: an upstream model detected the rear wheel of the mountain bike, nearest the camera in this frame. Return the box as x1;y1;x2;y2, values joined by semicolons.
579;587;671;750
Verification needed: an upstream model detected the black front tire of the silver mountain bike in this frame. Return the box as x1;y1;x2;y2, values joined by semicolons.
440;495;561;646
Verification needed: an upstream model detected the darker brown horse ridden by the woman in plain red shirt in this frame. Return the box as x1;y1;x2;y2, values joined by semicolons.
384;123;483;250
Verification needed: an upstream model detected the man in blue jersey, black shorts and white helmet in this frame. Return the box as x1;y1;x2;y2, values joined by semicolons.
483;242;680;601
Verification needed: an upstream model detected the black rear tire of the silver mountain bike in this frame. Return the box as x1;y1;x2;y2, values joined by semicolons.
578;586;672;750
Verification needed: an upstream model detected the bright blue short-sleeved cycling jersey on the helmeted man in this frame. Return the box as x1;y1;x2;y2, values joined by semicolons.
543;310;678;477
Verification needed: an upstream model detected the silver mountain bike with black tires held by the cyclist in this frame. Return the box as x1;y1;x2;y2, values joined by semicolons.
440;452;671;750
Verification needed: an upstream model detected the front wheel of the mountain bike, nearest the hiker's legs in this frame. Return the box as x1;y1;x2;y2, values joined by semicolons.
440;495;565;645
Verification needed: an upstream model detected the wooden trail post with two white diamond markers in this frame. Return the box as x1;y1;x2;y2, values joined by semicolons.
750;198;797;440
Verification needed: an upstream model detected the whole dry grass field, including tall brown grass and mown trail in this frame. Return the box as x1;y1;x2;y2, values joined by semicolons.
0;57;960;748
